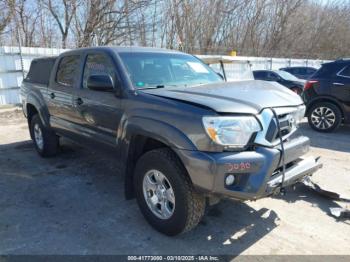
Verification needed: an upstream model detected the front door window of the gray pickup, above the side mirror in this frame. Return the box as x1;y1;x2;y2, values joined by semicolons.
83;54;115;88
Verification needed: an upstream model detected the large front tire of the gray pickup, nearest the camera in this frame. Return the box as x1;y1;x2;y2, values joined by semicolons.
134;148;206;236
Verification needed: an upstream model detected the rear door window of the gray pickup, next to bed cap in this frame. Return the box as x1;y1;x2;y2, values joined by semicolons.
56;55;80;86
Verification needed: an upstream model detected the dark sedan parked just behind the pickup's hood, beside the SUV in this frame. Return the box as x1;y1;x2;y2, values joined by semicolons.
253;70;305;95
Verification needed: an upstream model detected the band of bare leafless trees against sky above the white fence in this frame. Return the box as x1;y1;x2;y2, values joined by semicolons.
0;0;350;59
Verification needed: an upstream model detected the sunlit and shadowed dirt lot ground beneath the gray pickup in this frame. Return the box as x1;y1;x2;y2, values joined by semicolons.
0;107;350;255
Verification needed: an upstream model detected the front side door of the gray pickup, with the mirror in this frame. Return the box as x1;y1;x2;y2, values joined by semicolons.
73;52;122;147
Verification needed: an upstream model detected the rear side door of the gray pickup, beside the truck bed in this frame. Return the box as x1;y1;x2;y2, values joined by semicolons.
47;54;81;134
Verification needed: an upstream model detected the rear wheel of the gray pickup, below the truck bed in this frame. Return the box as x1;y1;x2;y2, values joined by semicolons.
29;114;59;157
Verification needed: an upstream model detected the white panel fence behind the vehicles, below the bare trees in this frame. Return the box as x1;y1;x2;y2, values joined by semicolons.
0;46;332;105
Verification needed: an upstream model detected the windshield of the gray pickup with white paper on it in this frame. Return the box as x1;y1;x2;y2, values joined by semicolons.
119;52;223;88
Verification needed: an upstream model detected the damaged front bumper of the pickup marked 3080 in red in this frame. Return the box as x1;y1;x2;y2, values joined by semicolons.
176;136;322;200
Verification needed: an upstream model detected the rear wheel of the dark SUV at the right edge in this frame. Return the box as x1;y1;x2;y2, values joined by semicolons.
308;102;342;133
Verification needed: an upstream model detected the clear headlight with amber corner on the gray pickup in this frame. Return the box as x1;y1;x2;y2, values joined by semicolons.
203;116;261;147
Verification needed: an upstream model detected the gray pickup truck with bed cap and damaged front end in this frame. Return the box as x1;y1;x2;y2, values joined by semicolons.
21;47;321;235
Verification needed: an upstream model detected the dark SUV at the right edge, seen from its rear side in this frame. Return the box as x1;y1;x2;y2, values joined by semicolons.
303;59;350;132
